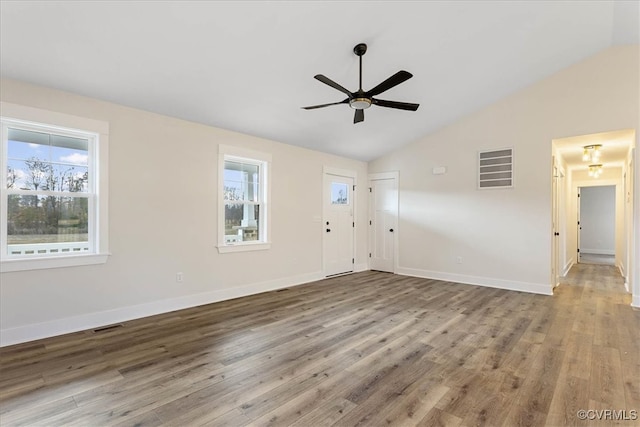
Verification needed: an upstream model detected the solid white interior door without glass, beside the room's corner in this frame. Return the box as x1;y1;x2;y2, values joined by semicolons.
369;177;398;273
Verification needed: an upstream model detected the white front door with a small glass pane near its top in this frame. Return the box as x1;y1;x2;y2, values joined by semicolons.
323;173;355;276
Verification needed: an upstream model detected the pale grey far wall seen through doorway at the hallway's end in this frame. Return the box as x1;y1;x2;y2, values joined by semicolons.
579;185;616;255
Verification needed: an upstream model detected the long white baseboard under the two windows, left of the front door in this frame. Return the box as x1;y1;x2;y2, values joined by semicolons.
0;272;324;347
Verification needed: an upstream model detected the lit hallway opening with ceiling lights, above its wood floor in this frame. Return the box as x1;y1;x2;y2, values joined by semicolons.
551;129;640;298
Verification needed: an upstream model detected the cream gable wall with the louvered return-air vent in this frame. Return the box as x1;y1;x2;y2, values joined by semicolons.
369;46;640;293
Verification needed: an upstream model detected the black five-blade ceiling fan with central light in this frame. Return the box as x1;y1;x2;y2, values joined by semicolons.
302;43;420;124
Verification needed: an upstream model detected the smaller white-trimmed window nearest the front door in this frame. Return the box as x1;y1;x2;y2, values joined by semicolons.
218;146;271;252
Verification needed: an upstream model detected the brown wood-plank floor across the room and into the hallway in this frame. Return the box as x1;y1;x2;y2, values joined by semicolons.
0;264;640;426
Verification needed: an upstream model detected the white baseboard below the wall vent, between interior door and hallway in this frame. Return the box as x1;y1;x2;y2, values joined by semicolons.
397;267;553;295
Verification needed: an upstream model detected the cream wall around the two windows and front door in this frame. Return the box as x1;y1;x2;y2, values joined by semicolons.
0;80;367;345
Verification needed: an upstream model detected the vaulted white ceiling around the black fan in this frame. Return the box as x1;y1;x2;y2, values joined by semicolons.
0;1;640;160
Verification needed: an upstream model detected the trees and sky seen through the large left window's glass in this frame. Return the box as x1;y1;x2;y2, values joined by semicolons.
6;128;91;254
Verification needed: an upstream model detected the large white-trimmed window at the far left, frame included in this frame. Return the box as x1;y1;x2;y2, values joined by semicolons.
0;103;106;271
